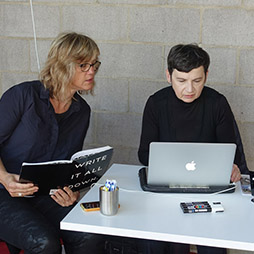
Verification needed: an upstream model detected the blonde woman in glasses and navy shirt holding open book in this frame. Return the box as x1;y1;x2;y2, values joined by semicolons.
0;33;104;254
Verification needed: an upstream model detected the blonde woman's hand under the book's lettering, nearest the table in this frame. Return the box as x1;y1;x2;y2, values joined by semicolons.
51;187;79;206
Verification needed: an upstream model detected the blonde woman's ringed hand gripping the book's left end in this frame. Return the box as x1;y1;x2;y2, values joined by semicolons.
1;172;39;197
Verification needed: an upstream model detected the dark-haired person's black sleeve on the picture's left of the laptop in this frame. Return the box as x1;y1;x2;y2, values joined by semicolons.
138;97;159;166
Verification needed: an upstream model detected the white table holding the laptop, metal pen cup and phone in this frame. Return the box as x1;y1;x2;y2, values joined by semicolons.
61;164;254;251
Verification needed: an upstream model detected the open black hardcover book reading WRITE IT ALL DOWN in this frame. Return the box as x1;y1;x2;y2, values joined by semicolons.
19;146;113;195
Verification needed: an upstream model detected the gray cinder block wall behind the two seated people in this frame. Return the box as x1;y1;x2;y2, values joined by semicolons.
0;0;254;170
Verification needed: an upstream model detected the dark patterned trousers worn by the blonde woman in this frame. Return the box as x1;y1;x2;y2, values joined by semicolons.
0;189;104;254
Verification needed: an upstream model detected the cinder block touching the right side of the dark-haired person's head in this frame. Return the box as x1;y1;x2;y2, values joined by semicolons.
204;48;237;84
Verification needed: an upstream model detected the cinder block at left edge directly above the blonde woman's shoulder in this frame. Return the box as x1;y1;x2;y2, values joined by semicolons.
0;72;38;93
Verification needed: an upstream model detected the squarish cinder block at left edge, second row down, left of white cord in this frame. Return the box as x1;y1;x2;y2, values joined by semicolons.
0;39;29;71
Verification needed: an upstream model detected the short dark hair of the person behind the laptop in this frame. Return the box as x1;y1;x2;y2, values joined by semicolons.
168;44;210;75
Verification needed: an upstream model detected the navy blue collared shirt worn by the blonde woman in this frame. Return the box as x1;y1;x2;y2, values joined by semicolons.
0;81;91;188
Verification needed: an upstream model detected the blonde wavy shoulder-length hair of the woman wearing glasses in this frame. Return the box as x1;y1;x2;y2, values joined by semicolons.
39;32;100;100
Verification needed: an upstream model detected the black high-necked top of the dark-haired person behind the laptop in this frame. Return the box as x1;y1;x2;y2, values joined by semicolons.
138;86;239;165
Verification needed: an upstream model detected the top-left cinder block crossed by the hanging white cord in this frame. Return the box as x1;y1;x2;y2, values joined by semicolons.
2;4;60;37
